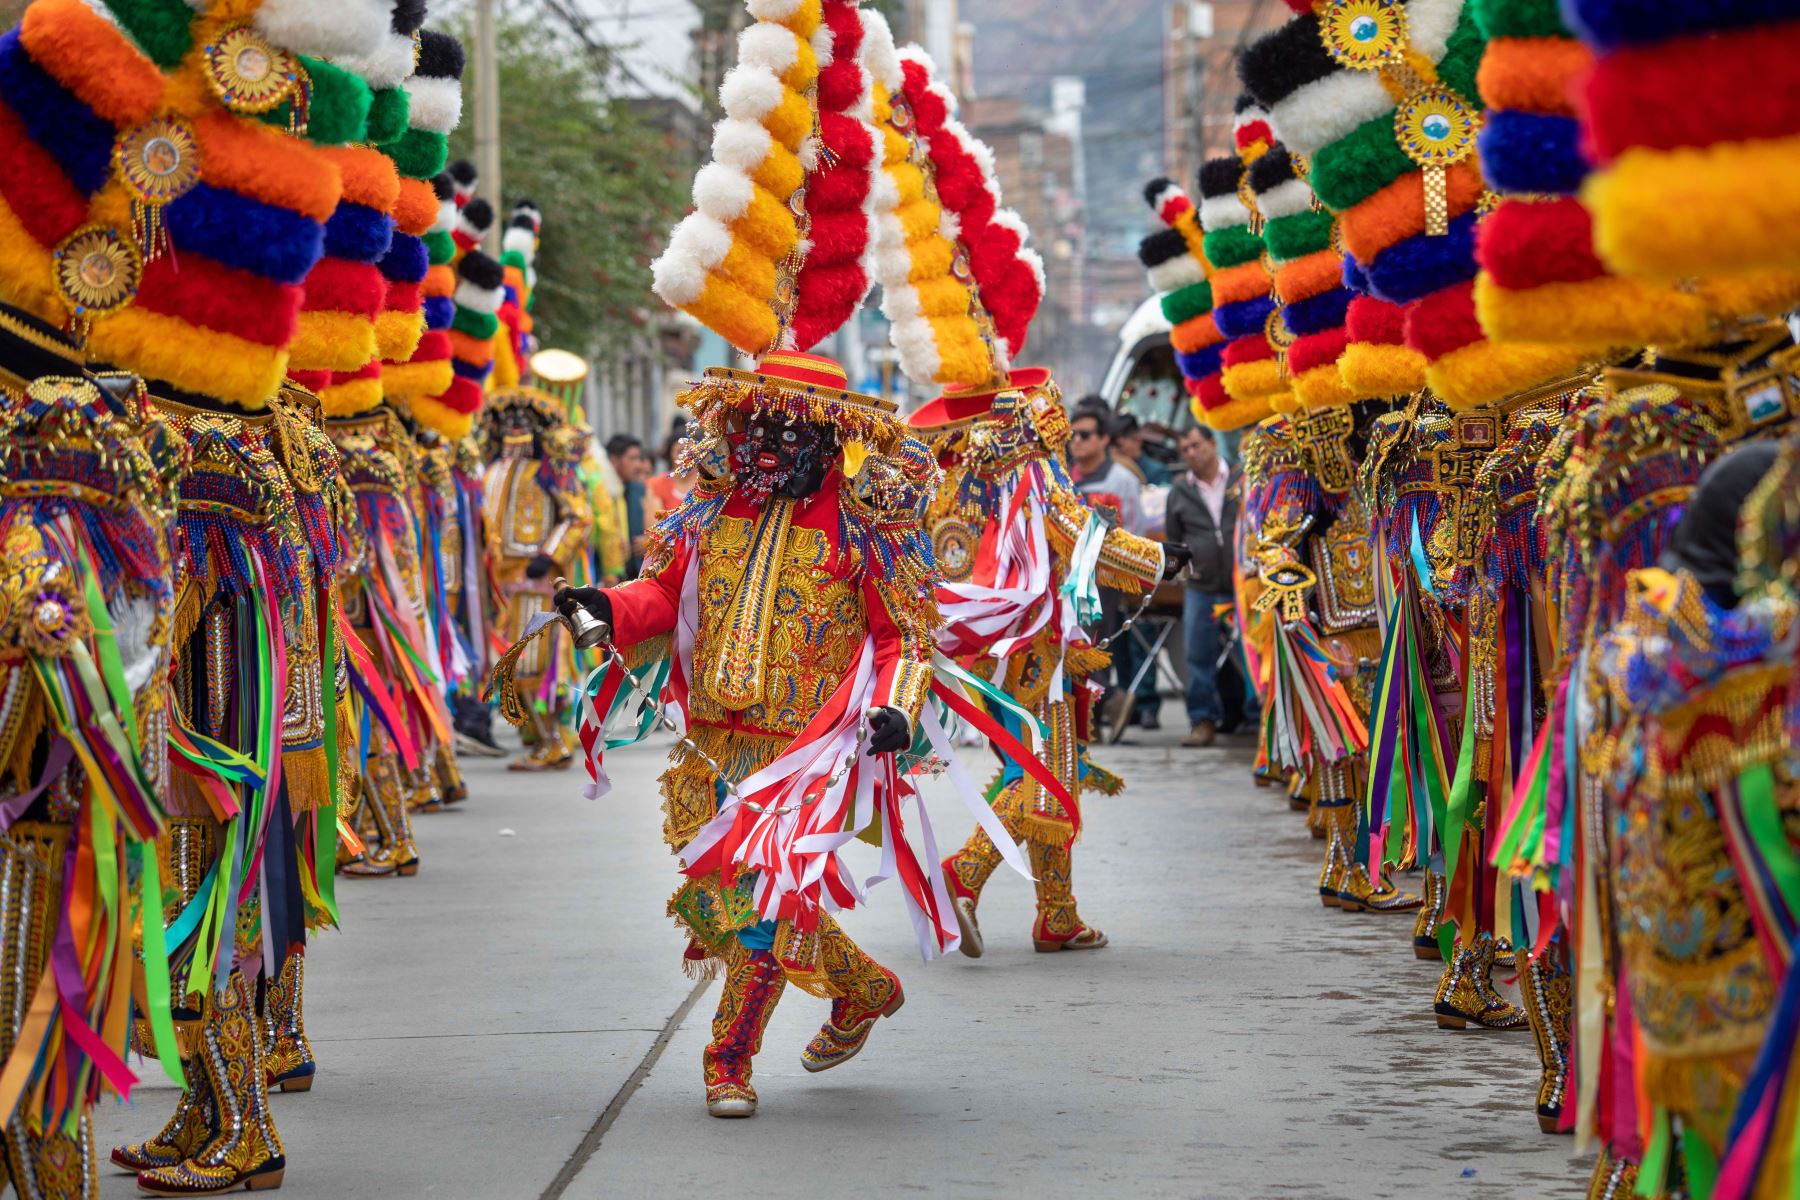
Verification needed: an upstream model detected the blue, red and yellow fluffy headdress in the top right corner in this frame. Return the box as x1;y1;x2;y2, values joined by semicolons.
1562;0;1800;282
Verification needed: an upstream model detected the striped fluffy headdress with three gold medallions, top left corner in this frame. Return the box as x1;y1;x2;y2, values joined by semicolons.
0;0;387;407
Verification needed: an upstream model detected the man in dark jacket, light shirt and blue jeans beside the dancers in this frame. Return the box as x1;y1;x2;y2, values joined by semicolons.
1168;425;1258;747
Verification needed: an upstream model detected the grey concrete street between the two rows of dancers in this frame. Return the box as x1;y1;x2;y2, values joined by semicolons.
97;734;1588;1200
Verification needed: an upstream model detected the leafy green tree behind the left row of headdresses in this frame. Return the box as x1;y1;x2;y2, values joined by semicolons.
450;14;691;351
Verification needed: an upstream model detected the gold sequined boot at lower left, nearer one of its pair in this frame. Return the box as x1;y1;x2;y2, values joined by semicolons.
137;972;288;1196
